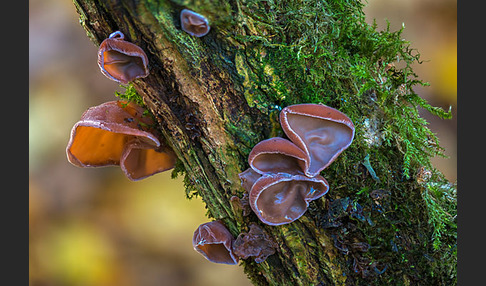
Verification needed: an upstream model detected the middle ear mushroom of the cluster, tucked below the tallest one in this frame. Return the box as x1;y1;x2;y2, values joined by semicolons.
248;137;307;175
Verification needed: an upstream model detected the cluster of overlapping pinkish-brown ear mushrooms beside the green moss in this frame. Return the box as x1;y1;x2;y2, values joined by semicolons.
239;104;354;225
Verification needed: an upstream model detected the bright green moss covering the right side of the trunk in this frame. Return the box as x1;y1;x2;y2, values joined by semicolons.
225;0;456;285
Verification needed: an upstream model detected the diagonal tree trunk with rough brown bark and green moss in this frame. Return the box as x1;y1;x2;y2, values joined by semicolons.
74;0;456;285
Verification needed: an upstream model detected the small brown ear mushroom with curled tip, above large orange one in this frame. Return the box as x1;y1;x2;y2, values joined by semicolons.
98;31;149;84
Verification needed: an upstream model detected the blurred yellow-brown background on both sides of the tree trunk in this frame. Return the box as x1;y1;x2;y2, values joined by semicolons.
29;0;457;286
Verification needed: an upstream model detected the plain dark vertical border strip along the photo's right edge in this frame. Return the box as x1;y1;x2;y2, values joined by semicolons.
457;1;486;285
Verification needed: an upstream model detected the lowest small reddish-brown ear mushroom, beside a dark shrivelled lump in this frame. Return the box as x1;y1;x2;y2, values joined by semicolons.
192;220;238;265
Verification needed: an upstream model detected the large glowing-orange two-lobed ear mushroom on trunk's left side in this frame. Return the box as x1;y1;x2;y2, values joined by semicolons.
66;101;176;181
